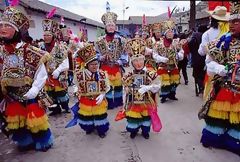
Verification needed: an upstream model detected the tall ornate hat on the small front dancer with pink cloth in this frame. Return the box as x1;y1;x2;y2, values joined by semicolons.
125;38;146;60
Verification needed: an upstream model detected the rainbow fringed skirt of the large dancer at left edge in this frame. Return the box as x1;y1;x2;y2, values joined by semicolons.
5;99;53;150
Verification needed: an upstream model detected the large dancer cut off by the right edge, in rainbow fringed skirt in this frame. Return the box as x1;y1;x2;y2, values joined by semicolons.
199;1;240;155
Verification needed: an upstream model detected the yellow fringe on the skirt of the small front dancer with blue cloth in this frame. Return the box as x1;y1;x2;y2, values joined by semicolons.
78;99;107;116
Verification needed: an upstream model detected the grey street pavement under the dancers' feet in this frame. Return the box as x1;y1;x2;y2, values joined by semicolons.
0;69;240;162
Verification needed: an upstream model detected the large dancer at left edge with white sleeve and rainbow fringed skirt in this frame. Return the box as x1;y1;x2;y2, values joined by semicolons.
0;7;53;151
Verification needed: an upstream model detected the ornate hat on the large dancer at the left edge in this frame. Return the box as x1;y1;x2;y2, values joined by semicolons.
0;7;30;33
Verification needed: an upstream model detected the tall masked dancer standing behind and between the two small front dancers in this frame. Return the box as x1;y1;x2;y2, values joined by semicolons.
96;12;128;109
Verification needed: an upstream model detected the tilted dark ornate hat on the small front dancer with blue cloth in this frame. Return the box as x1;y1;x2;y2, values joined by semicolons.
77;43;97;66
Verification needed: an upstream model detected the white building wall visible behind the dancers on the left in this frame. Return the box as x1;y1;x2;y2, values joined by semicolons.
28;11;97;41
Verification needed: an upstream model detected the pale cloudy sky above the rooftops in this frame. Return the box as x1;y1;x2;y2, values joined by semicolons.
40;0;190;22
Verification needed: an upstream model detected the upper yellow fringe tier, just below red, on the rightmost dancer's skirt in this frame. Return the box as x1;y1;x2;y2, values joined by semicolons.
211;101;240;112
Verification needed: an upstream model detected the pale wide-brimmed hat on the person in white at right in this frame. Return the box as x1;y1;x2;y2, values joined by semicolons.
209;6;229;21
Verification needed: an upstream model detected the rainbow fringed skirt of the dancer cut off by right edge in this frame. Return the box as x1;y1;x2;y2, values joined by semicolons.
201;88;240;155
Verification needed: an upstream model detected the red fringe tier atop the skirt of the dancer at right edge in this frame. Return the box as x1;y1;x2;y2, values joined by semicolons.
216;88;240;104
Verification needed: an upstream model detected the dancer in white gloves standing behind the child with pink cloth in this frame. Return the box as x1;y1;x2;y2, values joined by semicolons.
153;20;183;103
